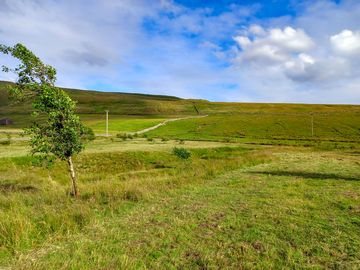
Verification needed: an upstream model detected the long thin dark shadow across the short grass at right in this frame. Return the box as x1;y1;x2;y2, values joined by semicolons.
249;171;360;181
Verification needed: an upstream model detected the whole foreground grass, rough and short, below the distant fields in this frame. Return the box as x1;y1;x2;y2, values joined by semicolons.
0;144;360;269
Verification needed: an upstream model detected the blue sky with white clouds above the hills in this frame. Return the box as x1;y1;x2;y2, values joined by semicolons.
0;0;360;104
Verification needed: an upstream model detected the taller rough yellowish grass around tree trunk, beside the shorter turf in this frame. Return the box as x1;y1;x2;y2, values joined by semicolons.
0;143;266;262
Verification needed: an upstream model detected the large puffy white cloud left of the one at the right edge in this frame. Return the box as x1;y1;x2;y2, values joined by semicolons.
234;25;315;77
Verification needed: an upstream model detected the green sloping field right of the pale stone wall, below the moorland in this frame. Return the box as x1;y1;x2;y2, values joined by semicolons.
149;112;360;142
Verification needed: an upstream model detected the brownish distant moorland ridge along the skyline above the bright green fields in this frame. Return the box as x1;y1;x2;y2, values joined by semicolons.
0;81;360;116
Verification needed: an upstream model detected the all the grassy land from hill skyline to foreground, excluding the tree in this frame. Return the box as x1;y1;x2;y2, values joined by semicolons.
0;83;360;269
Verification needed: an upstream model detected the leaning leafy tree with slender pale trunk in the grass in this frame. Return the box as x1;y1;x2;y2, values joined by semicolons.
0;44;93;196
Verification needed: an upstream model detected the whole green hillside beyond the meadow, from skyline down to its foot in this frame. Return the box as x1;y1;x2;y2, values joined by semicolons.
0;82;360;142
